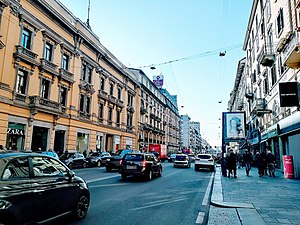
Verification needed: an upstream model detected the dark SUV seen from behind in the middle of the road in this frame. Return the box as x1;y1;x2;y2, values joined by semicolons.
119;153;162;180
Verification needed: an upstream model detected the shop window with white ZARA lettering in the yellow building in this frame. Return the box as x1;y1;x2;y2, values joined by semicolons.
6;123;25;150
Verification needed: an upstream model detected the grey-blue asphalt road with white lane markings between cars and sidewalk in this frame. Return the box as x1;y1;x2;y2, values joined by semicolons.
64;163;212;225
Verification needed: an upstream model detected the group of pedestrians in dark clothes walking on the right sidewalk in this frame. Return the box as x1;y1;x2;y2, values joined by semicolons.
226;149;276;178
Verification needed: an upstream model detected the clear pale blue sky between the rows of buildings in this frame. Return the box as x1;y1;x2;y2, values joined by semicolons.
60;0;252;147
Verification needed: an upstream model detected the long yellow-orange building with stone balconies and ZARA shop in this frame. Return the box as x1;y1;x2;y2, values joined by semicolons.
0;0;139;153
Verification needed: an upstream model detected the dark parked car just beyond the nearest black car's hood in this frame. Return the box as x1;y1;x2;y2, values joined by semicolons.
59;150;87;169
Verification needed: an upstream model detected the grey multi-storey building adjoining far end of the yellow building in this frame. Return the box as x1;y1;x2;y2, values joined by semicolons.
130;68;179;153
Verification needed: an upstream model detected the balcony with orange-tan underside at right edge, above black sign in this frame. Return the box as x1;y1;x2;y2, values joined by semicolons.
282;31;300;69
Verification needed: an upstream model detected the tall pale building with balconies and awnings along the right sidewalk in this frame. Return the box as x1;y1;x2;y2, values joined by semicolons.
229;0;300;178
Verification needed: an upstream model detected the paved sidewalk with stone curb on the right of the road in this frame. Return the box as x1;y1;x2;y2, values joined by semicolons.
208;167;300;225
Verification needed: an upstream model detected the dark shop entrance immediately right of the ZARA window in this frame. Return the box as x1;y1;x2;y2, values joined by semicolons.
31;126;49;151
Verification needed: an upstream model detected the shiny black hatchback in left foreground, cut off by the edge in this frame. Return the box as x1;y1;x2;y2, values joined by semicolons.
0;151;90;225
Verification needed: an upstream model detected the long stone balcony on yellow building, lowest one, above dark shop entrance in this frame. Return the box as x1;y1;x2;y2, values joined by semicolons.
29;96;65;115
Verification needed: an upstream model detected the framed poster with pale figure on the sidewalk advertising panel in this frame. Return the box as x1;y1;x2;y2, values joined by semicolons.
223;112;246;141
